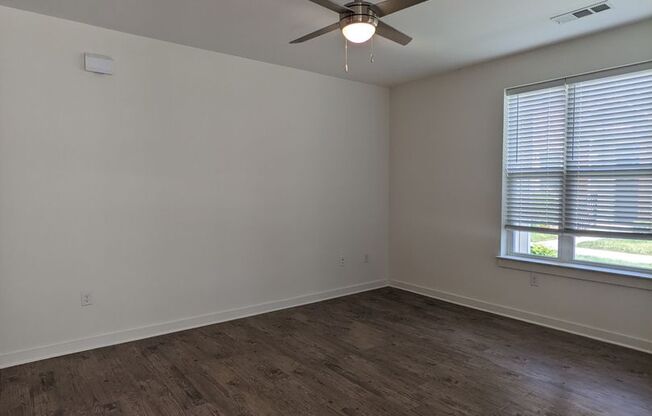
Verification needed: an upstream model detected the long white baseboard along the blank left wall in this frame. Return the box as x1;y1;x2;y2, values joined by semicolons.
0;280;388;369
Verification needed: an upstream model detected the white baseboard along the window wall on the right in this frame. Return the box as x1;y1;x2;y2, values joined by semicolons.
389;280;652;354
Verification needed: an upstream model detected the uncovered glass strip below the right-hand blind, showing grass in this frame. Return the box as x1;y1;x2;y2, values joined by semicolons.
575;237;652;269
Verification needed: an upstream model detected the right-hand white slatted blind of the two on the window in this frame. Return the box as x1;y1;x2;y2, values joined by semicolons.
564;71;652;233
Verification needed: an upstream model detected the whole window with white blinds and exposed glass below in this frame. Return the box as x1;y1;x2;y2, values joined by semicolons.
503;63;652;273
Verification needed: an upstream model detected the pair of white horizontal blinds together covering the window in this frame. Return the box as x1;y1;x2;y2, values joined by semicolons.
504;69;652;236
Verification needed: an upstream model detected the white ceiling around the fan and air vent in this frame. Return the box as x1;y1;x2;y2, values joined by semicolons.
0;0;652;85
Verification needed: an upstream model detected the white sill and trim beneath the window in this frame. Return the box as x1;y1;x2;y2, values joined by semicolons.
497;256;652;291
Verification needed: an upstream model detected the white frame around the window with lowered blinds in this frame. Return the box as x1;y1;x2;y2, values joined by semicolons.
498;61;652;280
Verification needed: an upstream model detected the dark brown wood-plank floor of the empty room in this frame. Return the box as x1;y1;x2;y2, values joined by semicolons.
0;288;652;416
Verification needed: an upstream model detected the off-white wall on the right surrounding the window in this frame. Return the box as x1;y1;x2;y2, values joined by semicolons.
390;20;652;351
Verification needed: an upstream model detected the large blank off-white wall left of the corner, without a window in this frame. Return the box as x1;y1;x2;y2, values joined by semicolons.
0;7;389;367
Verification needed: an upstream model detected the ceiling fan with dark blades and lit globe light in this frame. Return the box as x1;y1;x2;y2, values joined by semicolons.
290;0;428;46
